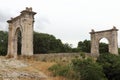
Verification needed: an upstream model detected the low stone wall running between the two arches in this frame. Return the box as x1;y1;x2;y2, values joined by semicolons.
33;53;80;62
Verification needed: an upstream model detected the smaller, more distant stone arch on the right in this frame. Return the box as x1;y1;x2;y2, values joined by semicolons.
90;27;118;56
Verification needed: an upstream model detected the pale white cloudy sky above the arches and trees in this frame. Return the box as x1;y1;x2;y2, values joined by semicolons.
0;0;120;47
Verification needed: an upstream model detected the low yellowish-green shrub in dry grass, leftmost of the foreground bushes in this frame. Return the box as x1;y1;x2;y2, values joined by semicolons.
48;64;79;80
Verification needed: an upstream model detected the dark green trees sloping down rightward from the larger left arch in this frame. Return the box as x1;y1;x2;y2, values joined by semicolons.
33;32;71;54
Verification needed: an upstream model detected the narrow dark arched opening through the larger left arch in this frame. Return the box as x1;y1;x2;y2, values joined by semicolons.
17;28;22;55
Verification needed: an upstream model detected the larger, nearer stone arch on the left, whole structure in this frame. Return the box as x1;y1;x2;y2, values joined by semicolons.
7;7;36;57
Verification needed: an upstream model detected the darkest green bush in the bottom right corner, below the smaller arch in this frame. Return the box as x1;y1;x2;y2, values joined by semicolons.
97;53;120;80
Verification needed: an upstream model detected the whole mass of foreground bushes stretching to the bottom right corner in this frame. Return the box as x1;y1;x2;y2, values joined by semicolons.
49;53;120;80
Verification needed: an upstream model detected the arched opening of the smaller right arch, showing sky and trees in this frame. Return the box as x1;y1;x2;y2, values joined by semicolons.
99;38;109;54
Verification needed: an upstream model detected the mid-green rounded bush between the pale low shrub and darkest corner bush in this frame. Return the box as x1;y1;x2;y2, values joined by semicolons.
72;58;107;80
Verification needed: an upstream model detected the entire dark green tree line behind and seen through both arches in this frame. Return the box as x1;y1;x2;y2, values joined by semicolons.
0;31;116;55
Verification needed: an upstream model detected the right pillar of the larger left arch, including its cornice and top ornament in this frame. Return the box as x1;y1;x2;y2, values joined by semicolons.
21;8;36;56
